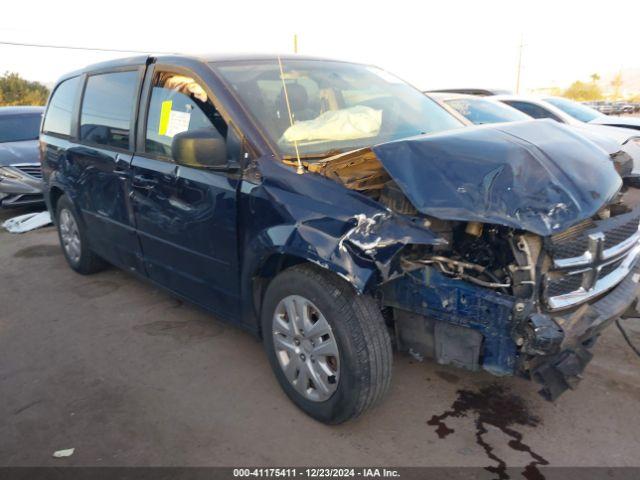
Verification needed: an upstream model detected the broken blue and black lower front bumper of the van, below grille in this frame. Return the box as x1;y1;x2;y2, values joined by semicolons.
380;259;640;400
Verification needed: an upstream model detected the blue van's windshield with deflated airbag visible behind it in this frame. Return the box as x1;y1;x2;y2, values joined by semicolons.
214;60;463;157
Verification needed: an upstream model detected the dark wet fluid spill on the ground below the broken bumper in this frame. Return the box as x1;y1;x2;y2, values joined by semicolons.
427;384;549;480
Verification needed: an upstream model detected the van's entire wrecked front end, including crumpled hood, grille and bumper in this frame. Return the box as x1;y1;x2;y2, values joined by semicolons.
294;122;640;400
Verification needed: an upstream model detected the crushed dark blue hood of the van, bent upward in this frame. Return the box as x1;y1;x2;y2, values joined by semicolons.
373;120;622;236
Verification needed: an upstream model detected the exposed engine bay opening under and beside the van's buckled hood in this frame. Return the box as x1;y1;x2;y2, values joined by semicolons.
290;143;635;308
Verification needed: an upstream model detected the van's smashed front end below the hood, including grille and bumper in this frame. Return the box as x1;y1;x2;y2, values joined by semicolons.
380;213;640;400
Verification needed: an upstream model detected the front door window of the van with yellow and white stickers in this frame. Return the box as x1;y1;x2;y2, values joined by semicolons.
145;72;227;158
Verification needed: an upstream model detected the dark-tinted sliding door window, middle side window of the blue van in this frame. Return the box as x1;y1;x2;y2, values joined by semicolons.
80;71;138;149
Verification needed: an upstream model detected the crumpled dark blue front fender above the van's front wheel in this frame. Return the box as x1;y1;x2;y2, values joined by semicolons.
239;158;445;328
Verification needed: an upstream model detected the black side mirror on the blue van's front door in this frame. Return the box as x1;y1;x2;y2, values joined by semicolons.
171;128;228;168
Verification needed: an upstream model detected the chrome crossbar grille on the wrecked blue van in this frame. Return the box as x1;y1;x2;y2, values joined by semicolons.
543;210;640;310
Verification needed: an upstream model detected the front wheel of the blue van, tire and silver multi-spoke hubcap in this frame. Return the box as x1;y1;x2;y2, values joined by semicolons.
262;265;393;424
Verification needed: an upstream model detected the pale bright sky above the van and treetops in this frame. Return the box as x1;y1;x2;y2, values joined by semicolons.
0;0;640;91
